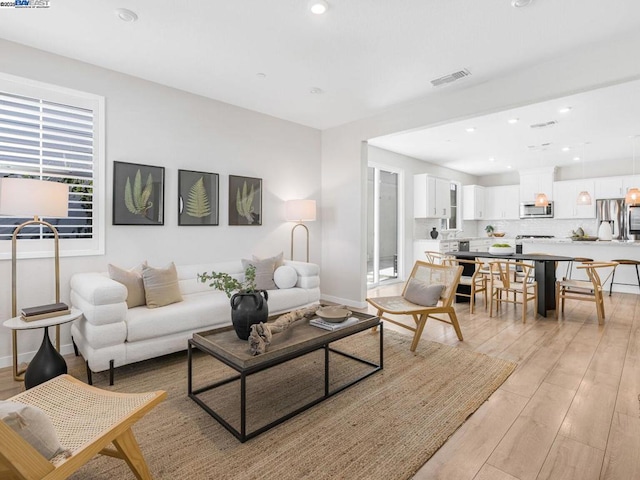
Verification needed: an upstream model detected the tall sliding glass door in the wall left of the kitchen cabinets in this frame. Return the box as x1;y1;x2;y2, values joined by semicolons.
367;164;402;286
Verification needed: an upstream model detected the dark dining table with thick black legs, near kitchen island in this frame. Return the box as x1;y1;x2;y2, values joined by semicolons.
445;252;574;317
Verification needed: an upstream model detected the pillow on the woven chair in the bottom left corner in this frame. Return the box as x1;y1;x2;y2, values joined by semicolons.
0;400;71;460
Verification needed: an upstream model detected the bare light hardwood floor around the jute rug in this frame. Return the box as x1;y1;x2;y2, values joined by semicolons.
0;284;640;480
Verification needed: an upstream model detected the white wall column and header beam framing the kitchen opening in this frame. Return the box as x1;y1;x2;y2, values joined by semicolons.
322;33;640;305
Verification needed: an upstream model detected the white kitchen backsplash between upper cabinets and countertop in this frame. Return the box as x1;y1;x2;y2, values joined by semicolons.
413;218;598;239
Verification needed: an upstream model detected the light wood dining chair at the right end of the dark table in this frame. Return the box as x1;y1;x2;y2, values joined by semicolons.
556;262;618;325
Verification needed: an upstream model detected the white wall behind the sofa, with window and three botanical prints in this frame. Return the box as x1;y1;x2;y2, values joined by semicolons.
0;40;321;366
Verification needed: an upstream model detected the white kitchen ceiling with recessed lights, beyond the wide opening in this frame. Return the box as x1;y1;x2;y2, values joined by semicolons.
369;81;640;176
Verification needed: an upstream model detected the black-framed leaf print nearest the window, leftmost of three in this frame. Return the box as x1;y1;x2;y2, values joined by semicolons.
113;162;164;225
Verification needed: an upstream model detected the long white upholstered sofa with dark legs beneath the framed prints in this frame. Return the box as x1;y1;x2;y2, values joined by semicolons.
71;260;320;384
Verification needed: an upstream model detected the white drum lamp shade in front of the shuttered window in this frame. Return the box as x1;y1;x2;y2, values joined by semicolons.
0;177;69;217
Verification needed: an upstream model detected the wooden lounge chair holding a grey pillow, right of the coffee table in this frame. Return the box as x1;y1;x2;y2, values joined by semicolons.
367;260;462;352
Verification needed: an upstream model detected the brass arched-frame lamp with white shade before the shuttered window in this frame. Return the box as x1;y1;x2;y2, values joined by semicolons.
0;177;69;380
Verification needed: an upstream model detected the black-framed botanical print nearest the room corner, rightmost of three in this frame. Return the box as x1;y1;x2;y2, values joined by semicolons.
229;175;262;225
